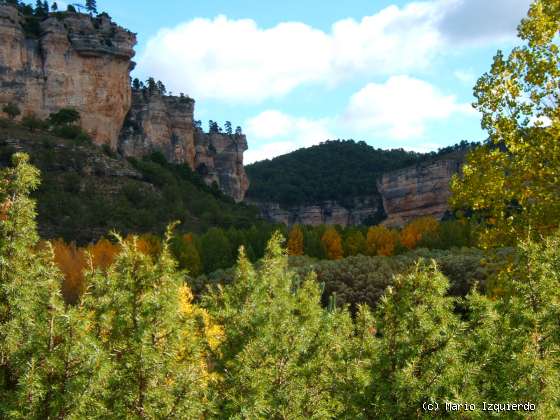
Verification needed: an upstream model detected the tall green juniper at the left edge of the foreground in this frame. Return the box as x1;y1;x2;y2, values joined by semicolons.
0;154;96;419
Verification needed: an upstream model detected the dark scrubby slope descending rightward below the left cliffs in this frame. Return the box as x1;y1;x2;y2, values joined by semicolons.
0;120;259;243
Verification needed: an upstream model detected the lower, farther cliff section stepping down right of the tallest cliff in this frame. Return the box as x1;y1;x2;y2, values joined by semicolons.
118;89;249;201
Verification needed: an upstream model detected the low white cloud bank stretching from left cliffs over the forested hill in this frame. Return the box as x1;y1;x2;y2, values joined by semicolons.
245;76;478;163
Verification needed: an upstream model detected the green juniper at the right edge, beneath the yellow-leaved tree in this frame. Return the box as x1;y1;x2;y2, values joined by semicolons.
464;234;560;418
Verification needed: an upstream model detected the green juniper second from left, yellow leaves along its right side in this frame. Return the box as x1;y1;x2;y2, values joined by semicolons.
84;228;211;418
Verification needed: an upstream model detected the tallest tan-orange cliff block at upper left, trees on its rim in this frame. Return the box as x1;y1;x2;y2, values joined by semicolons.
0;4;136;148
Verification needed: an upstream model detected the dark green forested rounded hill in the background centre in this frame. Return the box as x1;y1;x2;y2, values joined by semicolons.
246;140;476;207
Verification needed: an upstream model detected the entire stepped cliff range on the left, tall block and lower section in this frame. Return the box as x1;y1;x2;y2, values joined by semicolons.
0;4;249;201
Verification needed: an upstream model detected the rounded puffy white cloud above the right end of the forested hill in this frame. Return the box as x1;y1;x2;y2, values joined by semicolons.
341;76;474;140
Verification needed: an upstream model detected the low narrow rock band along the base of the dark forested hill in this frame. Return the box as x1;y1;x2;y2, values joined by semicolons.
249;196;382;226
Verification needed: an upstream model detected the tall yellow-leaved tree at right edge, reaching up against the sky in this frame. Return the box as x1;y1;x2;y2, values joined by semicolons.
451;0;560;246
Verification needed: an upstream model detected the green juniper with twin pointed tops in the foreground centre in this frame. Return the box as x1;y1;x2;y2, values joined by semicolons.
206;234;353;419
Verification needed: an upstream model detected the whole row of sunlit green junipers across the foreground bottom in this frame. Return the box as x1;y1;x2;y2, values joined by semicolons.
0;154;560;419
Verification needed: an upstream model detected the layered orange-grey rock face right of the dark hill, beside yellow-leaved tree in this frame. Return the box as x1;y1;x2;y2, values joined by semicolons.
377;159;462;226
